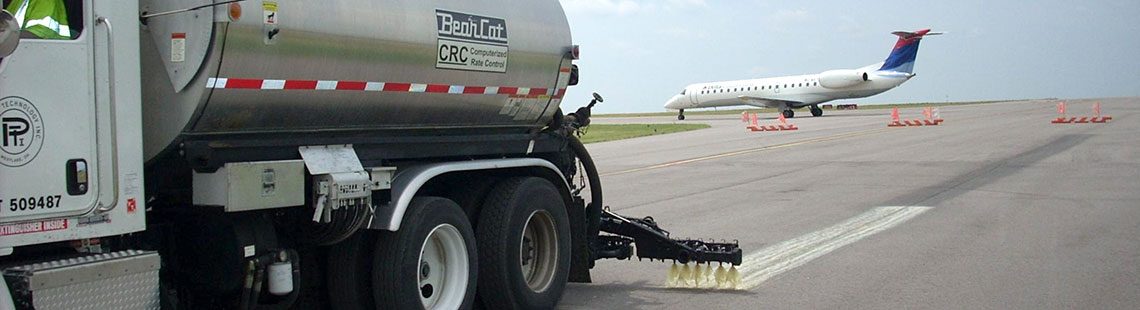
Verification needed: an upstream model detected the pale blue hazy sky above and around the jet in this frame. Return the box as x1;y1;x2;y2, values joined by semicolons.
561;0;1140;113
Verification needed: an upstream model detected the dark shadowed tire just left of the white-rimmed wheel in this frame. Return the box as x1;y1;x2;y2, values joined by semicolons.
325;230;376;310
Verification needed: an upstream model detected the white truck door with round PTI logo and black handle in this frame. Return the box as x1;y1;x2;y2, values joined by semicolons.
0;0;103;224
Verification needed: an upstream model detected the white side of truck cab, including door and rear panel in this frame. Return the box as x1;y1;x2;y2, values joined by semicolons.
0;0;146;254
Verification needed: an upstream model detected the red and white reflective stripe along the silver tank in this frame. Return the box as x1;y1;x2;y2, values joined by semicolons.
206;78;567;98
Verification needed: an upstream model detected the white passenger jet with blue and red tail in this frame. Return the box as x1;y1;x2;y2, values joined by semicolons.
665;28;943;121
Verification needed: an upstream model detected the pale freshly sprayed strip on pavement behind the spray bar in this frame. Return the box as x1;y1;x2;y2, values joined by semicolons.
740;206;930;289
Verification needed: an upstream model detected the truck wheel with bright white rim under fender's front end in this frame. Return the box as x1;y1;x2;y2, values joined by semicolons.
372;197;479;309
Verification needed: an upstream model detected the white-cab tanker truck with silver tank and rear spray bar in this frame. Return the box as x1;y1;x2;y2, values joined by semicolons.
0;0;741;309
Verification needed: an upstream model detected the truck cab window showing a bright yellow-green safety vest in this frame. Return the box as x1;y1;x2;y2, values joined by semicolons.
3;0;83;40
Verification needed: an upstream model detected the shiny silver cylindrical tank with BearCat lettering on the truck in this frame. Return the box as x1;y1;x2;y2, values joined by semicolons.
140;0;572;158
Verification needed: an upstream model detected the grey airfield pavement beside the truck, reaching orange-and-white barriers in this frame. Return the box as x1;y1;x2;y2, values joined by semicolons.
560;98;1140;310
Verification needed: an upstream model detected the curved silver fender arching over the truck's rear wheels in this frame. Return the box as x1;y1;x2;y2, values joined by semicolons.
367;158;570;231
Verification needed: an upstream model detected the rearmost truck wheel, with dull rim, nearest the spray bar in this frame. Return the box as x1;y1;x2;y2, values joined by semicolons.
477;178;570;309
